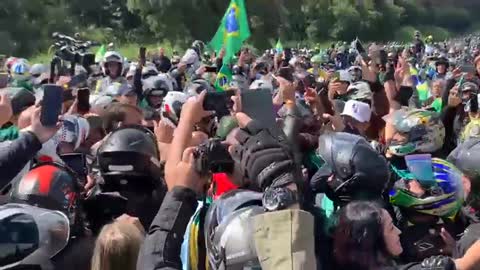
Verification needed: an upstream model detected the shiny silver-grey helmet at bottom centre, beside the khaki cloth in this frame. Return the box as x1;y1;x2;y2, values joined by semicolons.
204;189;265;270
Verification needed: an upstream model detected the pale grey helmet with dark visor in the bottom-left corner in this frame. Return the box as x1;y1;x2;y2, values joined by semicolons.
0;203;71;270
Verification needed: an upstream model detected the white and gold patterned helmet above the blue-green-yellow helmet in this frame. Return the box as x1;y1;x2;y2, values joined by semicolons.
388;110;445;156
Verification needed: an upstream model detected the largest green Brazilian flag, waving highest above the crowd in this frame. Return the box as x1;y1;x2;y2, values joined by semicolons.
210;0;250;64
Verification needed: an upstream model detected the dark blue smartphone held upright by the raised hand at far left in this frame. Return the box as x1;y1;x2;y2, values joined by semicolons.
40;84;63;127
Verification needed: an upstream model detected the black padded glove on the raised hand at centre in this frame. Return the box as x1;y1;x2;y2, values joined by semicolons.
230;117;295;191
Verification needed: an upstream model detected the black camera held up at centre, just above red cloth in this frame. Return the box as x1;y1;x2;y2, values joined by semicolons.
193;139;234;176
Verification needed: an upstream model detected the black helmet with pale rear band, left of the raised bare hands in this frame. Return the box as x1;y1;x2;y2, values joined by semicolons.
97;125;162;192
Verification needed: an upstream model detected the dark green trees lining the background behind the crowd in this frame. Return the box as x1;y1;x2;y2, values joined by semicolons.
0;0;480;57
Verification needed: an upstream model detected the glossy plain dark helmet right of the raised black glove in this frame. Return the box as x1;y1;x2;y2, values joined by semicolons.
311;132;390;203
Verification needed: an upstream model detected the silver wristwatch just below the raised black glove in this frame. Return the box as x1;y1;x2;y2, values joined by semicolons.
262;187;298;211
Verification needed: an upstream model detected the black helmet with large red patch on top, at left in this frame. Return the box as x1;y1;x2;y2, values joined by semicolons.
9;162;81;225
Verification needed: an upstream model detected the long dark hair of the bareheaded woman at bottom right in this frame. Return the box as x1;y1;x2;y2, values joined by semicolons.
333;201;389;270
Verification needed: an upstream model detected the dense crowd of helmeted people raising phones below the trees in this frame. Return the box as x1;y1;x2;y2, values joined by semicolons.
0;32;480;270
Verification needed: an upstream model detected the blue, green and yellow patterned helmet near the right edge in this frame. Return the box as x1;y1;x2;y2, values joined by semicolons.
389;155;464;218
